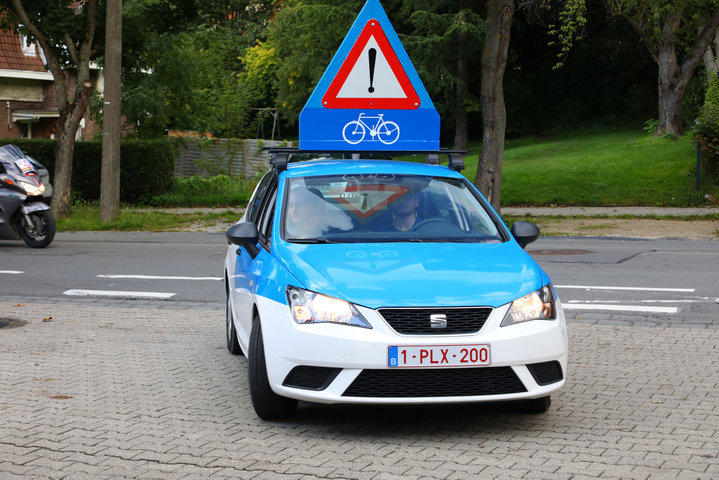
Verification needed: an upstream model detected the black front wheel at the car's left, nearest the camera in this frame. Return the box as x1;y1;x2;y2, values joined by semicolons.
247;316;297;420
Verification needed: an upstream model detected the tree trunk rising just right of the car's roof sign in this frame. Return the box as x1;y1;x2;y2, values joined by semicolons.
474;0;514;213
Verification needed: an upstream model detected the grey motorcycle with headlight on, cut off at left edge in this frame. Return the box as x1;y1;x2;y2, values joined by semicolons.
0;145;55;248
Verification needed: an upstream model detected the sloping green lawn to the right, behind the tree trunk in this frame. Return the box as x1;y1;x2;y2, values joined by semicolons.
463;131;702;206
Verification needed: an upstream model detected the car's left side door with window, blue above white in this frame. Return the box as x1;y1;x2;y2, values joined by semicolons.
231;172;277;348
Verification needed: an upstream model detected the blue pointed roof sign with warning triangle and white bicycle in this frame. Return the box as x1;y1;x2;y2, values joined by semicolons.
300;0;439;151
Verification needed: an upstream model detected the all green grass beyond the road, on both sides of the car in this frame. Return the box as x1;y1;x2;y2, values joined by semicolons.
52;130;719;230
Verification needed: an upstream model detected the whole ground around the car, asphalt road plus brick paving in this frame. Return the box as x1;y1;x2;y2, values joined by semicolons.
0;233;719;480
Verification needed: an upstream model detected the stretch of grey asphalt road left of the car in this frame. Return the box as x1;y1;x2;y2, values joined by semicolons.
0;232;227;304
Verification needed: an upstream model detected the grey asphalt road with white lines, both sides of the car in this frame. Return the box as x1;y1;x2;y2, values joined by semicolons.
0;232;719;326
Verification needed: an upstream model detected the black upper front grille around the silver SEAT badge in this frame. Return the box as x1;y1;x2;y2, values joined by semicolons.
379;307;492;335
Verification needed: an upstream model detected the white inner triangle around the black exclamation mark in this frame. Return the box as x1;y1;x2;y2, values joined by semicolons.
337;35;407;98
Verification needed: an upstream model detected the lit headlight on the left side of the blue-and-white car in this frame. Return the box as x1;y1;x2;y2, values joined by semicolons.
287;287;372;328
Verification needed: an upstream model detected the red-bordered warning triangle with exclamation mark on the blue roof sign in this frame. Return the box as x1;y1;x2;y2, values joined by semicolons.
322;19;420;110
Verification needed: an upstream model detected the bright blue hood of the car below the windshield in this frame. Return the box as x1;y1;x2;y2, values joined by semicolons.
280;241;548;308
